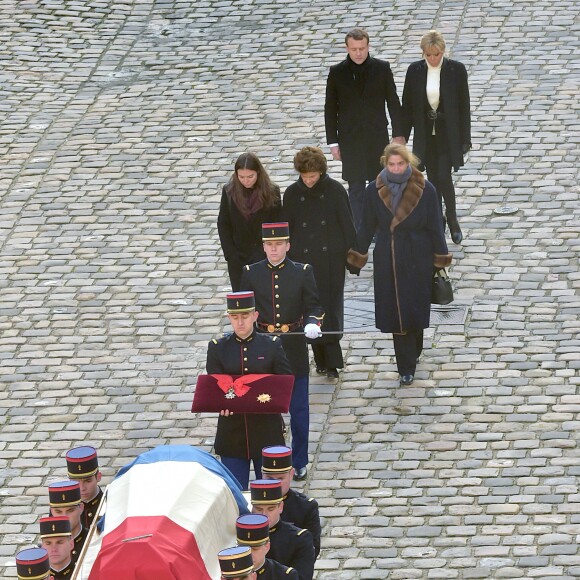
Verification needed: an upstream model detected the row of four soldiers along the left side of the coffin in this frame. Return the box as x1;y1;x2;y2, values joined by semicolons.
16;446;103;580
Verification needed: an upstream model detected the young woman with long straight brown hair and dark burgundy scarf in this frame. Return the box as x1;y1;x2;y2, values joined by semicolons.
218;153;282;292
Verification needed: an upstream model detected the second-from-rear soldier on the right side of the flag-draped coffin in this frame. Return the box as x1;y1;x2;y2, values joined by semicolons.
250;479;316;580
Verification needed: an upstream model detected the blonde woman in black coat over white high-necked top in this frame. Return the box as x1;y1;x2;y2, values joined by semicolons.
403;30;471;244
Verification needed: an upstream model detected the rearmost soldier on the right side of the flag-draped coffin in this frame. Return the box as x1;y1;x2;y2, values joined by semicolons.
262;445;321;558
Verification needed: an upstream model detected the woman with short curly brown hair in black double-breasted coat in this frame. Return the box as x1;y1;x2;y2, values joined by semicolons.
283;147;356;379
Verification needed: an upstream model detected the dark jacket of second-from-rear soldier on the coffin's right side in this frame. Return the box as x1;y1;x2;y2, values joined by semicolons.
268;520;316;580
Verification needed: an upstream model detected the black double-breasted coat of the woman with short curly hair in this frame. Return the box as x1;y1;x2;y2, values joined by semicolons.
282;174;356;344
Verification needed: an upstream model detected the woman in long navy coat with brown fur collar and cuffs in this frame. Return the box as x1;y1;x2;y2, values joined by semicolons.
348;144;451;385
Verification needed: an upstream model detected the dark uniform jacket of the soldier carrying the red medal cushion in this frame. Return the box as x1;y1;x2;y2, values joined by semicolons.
206;331;293;459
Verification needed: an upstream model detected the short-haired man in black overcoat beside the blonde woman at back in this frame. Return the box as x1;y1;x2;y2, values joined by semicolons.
324;28;406;227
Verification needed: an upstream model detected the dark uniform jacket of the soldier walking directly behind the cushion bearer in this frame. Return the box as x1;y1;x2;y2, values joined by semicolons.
241;258;324;376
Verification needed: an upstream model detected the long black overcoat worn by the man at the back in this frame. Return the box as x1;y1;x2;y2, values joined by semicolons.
324;56;403;181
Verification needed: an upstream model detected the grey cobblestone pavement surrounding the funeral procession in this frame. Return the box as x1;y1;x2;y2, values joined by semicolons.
0;0;580;579
